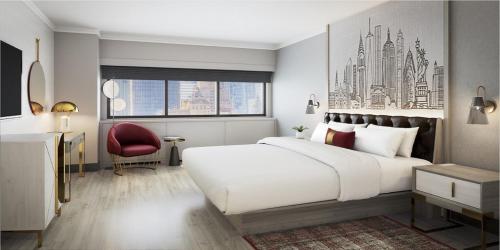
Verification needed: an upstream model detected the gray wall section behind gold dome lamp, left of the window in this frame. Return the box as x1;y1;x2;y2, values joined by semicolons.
54;32;100;163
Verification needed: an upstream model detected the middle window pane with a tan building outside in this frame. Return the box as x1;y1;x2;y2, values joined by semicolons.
168;81;217;116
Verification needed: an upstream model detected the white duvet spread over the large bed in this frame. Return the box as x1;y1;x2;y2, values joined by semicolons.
182;137;429;214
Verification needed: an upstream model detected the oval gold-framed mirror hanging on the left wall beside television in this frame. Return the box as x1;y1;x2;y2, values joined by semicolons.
28;39;46;115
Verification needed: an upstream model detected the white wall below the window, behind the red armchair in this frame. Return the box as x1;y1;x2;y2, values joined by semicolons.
99;117;276;167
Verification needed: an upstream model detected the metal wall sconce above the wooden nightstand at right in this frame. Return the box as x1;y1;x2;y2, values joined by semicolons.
467;86;497;124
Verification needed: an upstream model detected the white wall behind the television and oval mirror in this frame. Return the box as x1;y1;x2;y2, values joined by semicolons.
0;1;54;134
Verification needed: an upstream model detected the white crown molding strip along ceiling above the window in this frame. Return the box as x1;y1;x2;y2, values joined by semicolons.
100;32;276;50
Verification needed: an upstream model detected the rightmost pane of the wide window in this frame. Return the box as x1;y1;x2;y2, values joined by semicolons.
219;82;265;115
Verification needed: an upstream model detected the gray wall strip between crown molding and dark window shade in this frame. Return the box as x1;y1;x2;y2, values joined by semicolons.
100;40;275;71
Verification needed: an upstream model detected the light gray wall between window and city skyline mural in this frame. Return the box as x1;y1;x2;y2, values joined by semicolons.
272;33;328;136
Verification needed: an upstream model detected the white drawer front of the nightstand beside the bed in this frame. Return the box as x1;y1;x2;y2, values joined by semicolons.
415;170;481;209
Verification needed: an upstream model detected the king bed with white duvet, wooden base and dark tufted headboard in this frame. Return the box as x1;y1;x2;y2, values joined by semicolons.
183;113;440;234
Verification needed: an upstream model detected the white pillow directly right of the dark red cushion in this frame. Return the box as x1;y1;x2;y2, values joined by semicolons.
354;127;405;158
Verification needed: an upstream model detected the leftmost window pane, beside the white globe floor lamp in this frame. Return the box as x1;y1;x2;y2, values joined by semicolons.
109;79;165;117
